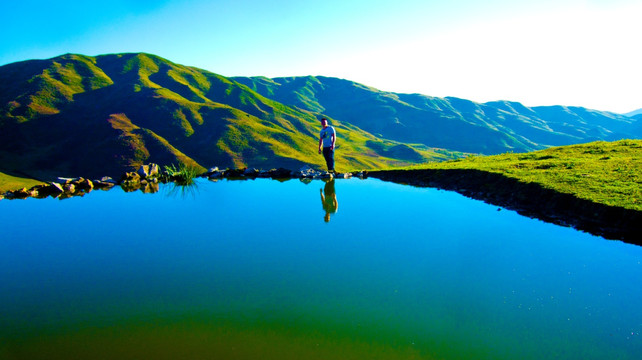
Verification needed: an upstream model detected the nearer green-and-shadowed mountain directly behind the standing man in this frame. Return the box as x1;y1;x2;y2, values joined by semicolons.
0;53;457;179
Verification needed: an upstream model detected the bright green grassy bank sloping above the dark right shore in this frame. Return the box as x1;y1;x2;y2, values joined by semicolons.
396;140;642;211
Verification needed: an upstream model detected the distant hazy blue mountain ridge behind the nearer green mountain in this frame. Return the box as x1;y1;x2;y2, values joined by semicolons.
233;76;642;154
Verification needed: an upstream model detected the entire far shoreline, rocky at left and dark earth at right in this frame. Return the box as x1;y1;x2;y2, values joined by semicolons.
0;164;642;246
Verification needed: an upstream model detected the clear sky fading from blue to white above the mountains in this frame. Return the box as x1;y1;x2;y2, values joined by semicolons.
0;0;642;112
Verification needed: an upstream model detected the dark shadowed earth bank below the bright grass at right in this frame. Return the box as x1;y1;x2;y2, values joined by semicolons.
368;169;642;246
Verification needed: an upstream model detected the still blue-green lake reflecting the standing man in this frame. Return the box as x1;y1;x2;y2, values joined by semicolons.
0;179;642;359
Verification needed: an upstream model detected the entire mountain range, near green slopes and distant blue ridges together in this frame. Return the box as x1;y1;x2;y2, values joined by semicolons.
0;53;642;179
